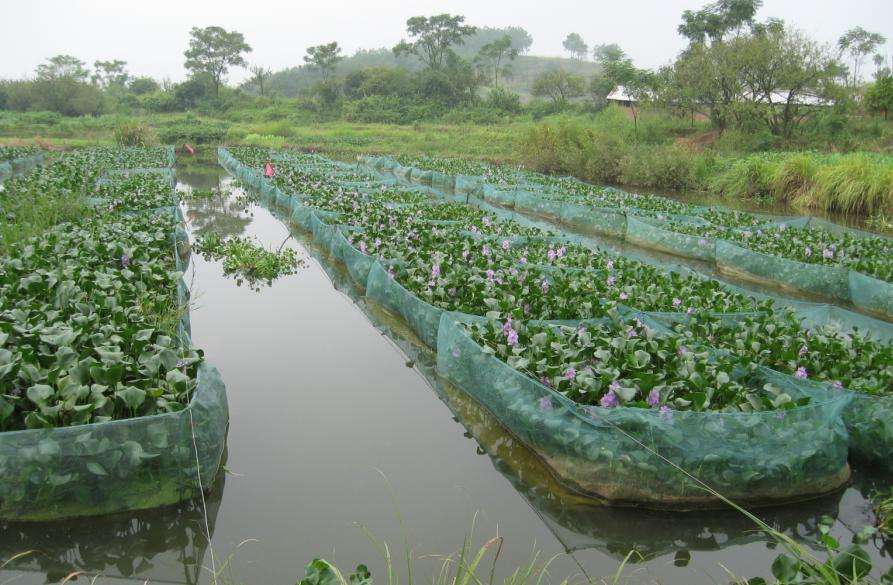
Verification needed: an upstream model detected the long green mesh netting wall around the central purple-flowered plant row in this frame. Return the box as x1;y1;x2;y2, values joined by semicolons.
219;149;893;509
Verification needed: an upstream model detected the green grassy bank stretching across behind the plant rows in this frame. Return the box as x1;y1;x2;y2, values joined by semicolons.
6;108;893;215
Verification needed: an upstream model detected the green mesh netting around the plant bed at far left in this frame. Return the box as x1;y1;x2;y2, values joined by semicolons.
0;160;229;521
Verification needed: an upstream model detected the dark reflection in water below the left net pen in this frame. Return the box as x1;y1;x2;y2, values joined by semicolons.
0;472;225;585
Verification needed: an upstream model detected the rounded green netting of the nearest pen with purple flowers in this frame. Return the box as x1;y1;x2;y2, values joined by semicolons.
437;314;849;509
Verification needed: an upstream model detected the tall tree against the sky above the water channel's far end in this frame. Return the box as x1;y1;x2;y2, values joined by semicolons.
183;26;251;97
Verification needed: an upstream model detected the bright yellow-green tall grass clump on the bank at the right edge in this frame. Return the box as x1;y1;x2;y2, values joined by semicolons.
795;153;893;214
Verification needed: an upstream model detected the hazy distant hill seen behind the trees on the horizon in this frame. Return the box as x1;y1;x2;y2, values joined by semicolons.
251;27;599;98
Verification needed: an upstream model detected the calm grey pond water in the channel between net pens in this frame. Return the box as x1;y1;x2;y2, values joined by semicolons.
0;159;893;585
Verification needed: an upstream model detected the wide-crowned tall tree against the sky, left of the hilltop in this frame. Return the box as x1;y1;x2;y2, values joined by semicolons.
394;14;477;69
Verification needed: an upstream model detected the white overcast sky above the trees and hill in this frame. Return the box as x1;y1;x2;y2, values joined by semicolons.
0;0;893;81
